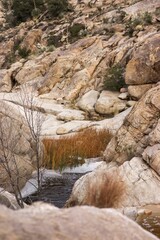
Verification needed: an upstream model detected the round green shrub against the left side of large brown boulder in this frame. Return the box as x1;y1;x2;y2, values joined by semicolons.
104;64;125;91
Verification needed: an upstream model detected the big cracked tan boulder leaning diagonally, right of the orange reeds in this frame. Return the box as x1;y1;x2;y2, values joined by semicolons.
104;85;160;163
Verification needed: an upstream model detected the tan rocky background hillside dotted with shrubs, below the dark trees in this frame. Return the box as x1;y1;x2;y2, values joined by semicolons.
0;0;160;105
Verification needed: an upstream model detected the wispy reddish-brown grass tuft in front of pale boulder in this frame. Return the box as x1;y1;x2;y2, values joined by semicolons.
82;172;126;208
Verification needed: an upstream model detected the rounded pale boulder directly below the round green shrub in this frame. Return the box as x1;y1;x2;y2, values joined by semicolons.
95;91;126;115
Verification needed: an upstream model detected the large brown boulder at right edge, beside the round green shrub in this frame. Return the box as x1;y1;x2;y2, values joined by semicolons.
125;33;160;85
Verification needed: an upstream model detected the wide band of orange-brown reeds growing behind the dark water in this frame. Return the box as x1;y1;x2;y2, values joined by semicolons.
43;128;112;169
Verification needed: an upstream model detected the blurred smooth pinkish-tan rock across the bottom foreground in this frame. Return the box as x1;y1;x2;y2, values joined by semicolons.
0;204;157;240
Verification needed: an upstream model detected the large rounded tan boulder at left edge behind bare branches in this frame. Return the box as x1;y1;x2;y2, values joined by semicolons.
0;101;35;192
